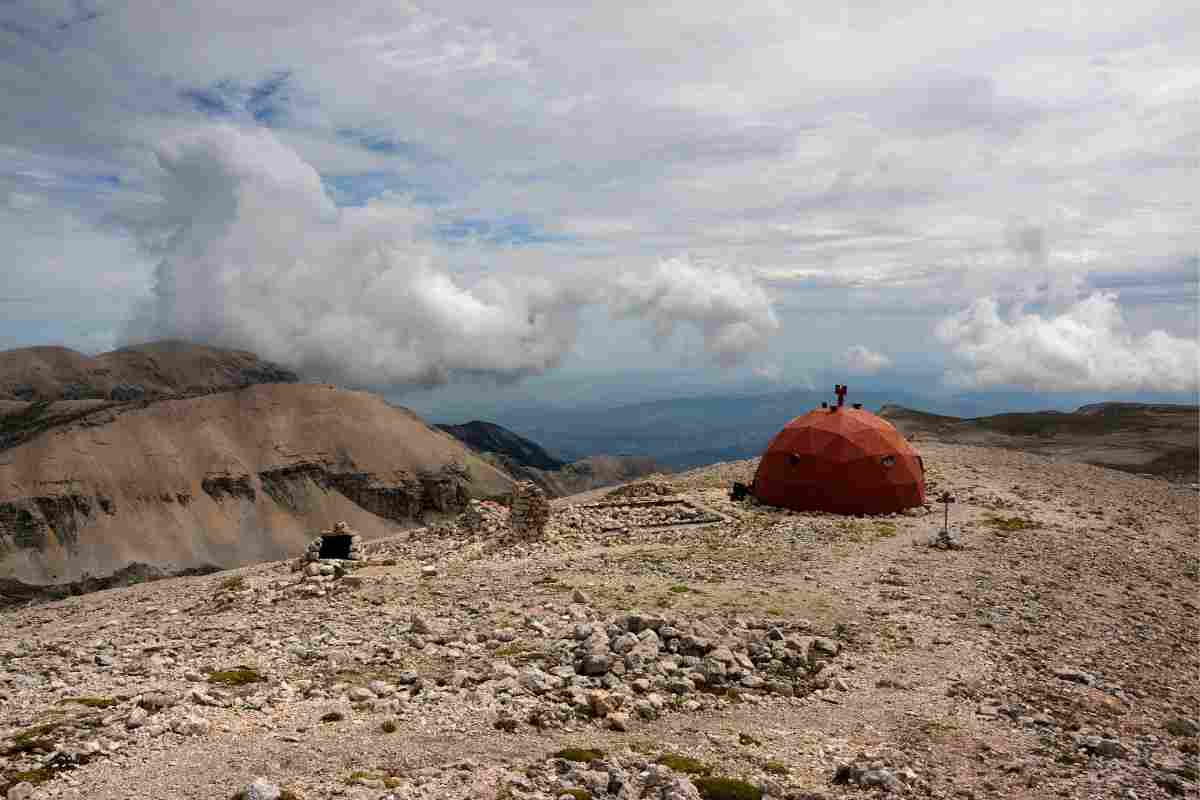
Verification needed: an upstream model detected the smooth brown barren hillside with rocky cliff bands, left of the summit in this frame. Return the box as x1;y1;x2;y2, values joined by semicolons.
0;384;511;583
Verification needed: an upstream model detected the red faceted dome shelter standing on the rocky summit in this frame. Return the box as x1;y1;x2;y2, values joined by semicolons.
751;385;925;515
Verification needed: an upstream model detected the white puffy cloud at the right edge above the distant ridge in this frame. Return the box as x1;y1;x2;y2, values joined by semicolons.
936;291;1200;392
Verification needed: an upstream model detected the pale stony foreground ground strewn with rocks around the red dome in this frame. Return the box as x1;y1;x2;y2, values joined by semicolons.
0;443;1200;800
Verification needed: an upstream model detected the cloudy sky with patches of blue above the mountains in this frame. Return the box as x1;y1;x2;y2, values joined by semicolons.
0;0;1200;407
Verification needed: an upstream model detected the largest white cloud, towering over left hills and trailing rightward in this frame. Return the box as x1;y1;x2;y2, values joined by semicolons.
128;125;778;386
